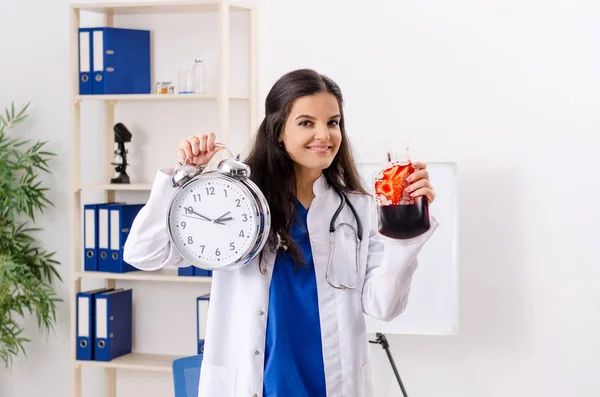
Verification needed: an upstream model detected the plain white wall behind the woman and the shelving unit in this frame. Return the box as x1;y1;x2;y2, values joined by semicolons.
0;0;600;397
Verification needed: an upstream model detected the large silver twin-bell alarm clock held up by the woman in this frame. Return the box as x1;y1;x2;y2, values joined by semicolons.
167;143;271;270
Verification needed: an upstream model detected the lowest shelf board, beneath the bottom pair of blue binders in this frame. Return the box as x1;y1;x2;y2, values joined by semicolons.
76;353;184;372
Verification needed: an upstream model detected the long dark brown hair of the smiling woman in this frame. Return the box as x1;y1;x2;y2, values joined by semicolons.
246;69;368;268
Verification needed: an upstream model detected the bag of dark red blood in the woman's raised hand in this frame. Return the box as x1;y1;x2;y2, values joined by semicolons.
375;163;430;239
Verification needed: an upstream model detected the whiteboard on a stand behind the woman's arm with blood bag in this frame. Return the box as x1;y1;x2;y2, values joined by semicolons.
358;163;458;335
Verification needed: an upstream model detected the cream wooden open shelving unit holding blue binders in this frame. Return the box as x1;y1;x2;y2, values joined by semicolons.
70;0;257;397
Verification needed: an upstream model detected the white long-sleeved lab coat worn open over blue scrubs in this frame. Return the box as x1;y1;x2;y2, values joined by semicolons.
124;168;438;397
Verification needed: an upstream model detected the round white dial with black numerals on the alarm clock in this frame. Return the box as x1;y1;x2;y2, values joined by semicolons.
169;176;257;268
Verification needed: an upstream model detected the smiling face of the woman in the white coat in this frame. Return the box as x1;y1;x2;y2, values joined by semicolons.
280;92;342;173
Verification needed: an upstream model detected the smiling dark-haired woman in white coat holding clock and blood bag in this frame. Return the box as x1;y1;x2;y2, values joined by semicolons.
124;69;438;397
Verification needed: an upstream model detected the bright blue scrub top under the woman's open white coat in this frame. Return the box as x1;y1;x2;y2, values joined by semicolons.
263;201;326;397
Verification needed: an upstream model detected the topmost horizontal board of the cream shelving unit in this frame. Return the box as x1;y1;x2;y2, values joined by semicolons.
71;0;249;15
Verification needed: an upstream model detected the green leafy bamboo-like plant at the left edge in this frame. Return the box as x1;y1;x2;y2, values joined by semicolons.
0;102;62;367
